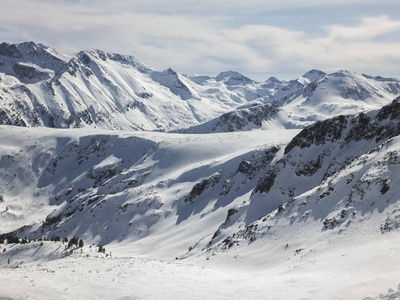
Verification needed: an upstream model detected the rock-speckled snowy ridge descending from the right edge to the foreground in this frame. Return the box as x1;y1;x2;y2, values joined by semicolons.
208;97;400;253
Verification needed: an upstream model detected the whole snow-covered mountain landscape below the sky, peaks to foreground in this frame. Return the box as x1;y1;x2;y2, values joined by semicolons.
0;42;400;300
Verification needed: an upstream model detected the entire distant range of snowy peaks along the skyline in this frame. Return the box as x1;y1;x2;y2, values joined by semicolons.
0;42;400;133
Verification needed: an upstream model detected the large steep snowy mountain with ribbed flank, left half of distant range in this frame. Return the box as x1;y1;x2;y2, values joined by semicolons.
0;42;266;131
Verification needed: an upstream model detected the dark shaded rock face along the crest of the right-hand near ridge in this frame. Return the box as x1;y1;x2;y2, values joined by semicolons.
260;99;400;197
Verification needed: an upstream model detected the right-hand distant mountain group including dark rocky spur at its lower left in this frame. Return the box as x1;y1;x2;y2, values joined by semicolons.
180;70;400;133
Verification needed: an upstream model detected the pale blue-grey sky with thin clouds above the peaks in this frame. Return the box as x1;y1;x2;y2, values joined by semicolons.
0;0;400;81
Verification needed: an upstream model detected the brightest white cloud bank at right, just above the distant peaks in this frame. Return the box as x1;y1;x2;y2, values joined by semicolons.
223;16;400;69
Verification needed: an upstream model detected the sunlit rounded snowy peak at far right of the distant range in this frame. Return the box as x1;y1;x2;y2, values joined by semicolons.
279;71;400;126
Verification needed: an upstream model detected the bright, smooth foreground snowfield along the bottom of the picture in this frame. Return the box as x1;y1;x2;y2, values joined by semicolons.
0;233;400;300
